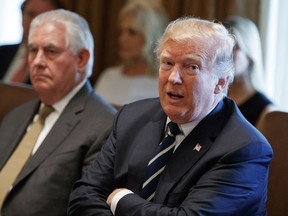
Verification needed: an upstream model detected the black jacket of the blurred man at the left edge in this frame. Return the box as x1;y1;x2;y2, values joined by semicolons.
0;44;20;79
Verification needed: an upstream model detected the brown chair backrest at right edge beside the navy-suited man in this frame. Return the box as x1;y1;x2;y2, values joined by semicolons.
260;111;288;216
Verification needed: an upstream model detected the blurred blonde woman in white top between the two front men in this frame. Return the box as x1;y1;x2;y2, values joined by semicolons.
95;0;168;106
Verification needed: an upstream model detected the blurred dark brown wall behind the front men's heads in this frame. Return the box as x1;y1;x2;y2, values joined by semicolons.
59;0;261;83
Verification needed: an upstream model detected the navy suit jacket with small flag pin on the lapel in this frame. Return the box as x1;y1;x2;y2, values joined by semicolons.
68;98;272;216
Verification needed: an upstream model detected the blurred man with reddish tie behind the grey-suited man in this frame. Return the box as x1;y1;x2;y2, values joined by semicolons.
0;0;64;83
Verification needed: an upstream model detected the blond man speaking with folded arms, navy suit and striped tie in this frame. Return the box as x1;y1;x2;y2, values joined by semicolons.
68;18;273;216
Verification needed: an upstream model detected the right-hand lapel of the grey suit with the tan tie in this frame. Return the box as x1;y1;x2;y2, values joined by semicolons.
15;84;91;184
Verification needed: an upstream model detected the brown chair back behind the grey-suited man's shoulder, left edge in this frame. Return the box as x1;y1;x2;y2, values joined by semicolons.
0;82;37;122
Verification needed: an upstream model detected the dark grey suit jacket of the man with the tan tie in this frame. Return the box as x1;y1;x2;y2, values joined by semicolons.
0;83;115;216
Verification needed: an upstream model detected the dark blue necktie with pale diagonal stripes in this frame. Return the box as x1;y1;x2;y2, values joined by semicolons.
142;122;181;201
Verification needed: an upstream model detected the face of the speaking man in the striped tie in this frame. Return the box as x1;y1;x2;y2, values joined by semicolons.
159;40;219;124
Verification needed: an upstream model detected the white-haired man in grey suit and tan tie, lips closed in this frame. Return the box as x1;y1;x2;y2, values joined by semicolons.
0;9;115;216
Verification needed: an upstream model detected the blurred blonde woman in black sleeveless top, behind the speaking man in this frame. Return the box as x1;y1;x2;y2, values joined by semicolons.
225;16;274;128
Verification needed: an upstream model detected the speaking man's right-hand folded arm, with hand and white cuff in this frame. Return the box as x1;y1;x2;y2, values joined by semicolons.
110;143;272;216
